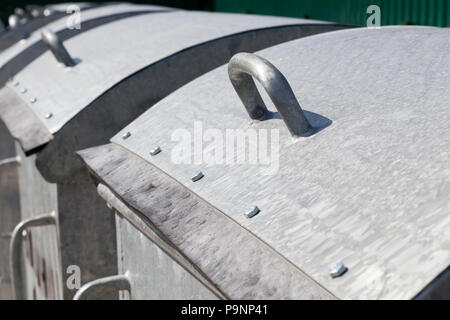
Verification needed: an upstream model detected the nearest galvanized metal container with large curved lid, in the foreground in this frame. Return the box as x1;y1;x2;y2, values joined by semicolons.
78;27;450;299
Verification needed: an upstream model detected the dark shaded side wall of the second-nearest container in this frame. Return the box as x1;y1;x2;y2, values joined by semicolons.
57;165;118;299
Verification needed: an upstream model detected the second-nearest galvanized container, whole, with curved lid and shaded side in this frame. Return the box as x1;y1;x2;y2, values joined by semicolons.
0;11;345;298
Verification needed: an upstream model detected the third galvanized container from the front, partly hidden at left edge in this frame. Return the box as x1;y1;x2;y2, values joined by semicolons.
0;4;171;297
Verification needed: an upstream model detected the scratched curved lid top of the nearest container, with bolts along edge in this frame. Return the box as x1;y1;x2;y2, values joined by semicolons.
112;27;450;299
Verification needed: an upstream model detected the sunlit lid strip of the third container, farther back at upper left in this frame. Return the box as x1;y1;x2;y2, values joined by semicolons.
0;4;170;66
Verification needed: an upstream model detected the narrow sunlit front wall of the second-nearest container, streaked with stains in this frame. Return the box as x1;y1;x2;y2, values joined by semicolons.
16;145;63;299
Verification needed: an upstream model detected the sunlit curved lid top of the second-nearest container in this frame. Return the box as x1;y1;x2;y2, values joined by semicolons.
9;11;323;133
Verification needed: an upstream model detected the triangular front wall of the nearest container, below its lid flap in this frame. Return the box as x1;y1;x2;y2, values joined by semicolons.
116;214;217;300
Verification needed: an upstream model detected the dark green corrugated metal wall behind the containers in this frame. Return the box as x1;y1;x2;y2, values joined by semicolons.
215;0;450;27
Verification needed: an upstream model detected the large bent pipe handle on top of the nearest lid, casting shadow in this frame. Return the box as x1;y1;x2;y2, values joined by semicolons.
228;53;311;136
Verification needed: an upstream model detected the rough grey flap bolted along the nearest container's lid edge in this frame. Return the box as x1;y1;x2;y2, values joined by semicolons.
78;144;335;299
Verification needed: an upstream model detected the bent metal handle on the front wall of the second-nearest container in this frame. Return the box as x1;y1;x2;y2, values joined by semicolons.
10;212;56;300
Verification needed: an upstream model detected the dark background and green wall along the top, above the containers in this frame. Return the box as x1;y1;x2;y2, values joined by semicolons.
0;0;450;27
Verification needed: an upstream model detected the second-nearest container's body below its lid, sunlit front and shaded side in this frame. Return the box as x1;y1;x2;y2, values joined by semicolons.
13;141;117;299
